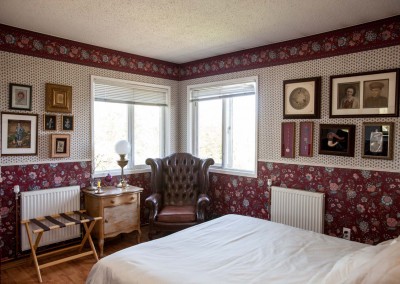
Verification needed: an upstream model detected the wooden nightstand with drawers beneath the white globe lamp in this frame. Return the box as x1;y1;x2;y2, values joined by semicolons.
83;186;143;257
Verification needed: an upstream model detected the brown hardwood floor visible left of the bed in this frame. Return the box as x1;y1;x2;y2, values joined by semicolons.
1;226;148;284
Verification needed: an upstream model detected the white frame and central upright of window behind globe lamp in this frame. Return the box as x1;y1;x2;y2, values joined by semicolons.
90;75;171;177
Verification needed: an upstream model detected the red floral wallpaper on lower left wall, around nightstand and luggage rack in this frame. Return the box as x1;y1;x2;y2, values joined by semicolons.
0;161;150;261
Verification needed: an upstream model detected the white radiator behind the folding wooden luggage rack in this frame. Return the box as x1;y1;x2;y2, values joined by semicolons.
20;186;81;251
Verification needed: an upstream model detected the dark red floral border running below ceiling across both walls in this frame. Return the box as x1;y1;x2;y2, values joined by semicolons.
0;16;400;80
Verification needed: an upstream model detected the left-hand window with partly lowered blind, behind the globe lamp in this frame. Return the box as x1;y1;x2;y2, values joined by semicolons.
92;76;170;175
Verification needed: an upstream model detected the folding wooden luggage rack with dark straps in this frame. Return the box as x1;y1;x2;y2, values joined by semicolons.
21;210;102;282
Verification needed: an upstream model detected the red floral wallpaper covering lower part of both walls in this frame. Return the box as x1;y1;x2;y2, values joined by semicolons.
0;162;400;261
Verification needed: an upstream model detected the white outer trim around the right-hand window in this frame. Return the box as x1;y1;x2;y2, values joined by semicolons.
186;76;258;178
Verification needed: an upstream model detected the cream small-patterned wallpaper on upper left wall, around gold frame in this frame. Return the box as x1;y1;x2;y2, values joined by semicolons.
0;51;178;166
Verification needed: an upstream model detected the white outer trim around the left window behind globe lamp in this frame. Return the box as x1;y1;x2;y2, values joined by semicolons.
90;75;171;178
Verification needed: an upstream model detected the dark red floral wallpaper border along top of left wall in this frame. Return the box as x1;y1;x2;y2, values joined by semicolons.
0;24;179;80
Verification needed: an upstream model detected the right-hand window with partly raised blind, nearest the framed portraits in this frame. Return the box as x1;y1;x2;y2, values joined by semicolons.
188;77;257;177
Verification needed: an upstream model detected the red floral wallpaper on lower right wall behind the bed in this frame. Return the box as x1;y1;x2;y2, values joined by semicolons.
210;162;400;244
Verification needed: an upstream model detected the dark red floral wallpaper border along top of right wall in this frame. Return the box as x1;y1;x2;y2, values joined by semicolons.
179;16;400;80
